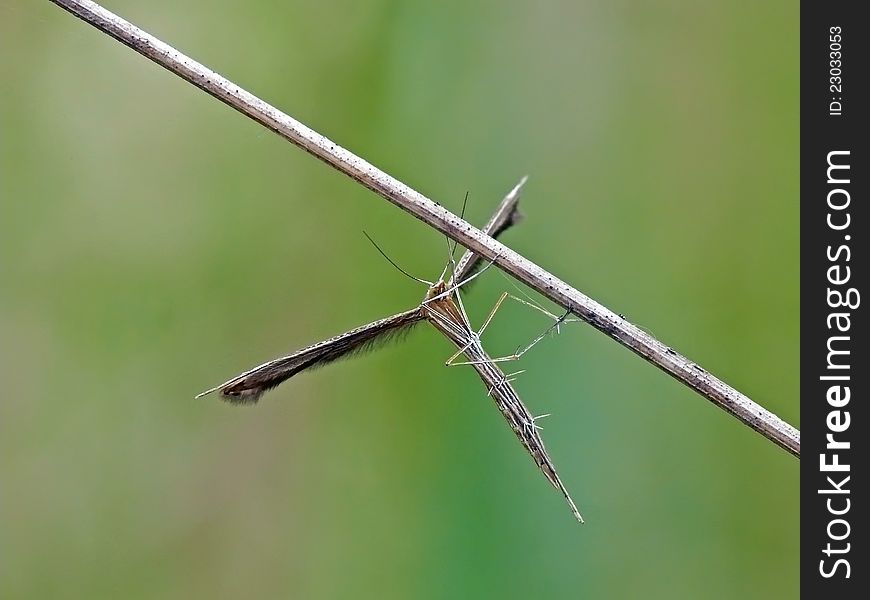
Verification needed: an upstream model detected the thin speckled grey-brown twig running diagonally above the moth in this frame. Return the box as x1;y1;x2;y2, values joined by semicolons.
44;0;800;457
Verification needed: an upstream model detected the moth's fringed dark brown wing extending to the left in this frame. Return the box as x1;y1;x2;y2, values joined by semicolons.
197;308;423;404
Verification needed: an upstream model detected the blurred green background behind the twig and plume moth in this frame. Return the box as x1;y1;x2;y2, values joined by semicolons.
0;0;800;598
